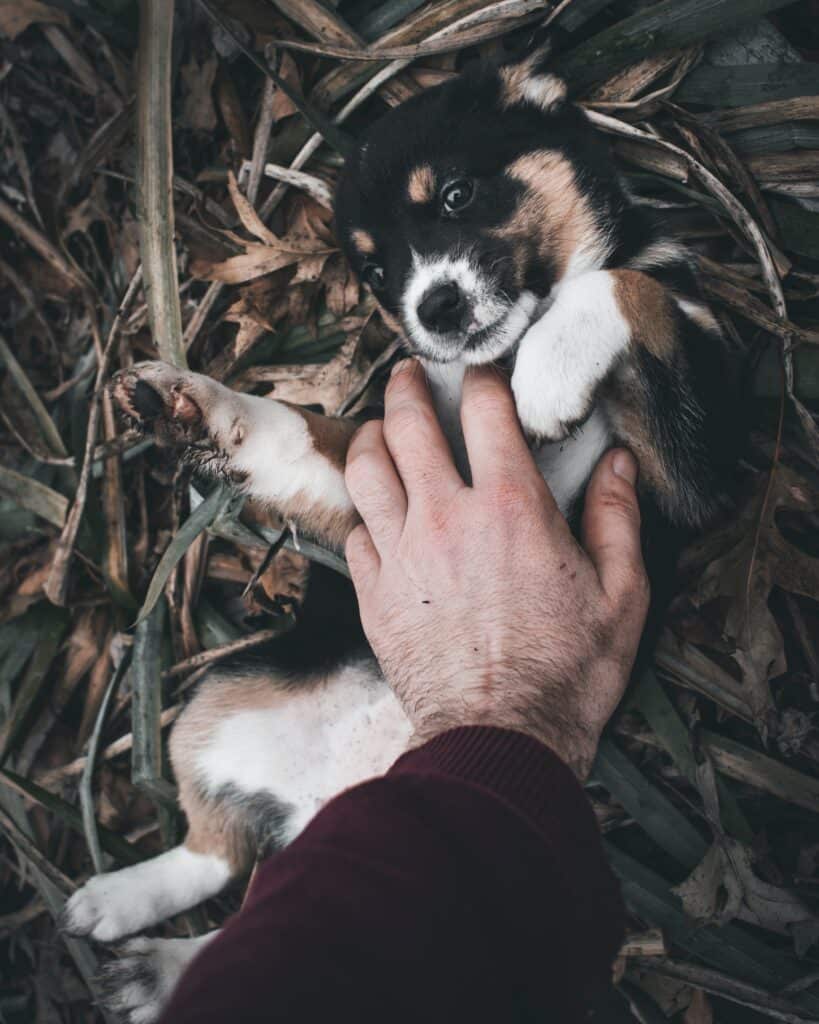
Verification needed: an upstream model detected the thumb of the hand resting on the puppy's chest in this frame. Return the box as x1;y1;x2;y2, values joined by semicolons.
583;449;648;611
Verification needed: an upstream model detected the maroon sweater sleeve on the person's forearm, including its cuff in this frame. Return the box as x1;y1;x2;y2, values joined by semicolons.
161;727;624;1024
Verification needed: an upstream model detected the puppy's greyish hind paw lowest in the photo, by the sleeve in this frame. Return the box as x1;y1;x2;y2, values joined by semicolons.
99;933;210;1024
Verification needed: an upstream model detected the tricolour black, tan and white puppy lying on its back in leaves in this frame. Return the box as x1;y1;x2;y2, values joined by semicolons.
64;44;732;1024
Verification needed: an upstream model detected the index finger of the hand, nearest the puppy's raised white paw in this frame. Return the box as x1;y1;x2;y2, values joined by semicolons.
461;367;540;486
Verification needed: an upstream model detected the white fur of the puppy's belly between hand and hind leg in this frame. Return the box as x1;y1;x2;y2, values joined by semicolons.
196;660;412;842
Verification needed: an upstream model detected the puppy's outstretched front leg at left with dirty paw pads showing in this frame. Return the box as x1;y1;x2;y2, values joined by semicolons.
113;362;358;550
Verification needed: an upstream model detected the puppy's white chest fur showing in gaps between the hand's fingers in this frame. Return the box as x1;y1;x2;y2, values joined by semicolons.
426;362;612;515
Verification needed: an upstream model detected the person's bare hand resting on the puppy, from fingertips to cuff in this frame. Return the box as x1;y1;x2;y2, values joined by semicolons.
346;360;649;778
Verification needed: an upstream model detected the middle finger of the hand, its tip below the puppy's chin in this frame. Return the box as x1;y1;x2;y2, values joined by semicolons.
384;359;464;505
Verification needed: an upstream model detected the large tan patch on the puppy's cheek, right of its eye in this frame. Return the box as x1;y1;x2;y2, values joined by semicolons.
497;150;601;279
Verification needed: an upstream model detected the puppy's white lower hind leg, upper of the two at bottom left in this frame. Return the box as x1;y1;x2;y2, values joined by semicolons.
63;846;230;942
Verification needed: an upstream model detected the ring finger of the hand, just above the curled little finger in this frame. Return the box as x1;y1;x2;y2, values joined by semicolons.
344;420;406;553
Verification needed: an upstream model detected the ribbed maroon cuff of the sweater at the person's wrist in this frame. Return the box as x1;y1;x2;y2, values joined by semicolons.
388;725;597;834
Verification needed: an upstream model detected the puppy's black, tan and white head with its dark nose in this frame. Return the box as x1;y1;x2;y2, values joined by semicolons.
336;55;615;364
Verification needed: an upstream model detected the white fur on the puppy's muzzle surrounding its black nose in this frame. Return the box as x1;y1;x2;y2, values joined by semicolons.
401;250;536;366
